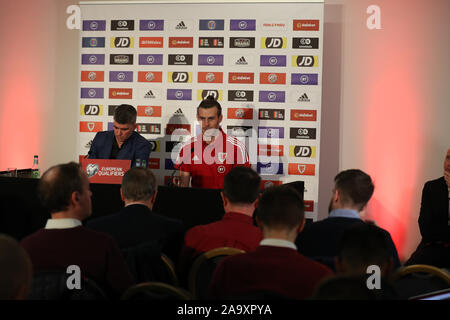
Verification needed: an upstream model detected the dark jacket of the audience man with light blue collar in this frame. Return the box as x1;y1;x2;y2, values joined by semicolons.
295;217;400;270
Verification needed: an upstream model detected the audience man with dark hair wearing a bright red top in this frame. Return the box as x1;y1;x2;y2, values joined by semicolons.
180;166;262;284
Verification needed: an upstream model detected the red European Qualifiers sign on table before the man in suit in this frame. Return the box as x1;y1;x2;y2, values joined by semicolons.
80;158;131;184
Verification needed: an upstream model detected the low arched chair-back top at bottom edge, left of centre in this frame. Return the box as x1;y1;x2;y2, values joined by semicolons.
121;282;193;300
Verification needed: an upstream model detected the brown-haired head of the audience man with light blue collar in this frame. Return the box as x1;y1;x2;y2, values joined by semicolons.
334;169;374;210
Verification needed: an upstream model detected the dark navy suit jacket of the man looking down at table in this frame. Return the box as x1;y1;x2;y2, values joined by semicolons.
88;131;152;167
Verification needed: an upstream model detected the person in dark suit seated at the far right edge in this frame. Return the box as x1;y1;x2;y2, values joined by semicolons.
405;149;450;268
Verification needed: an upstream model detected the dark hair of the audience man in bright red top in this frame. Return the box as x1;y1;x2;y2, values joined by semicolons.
223;166;261;204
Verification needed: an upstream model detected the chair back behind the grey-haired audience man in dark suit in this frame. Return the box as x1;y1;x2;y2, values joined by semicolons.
122;241;178;285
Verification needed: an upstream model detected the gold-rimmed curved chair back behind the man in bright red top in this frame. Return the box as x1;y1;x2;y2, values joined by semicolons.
188;247;245;299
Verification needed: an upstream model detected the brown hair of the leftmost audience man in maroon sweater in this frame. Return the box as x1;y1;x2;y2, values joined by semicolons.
38;162;83;213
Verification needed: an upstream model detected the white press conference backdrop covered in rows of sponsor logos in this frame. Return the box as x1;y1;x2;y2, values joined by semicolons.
78;1;323;220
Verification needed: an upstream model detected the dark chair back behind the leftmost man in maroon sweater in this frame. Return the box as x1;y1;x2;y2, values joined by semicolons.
28;270;108;300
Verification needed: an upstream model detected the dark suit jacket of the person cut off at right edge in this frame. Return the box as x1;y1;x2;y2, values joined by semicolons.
419;177;450;243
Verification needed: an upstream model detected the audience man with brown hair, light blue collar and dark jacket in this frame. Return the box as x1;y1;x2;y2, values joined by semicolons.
295;169;400;270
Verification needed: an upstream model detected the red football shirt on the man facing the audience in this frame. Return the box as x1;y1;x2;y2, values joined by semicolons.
175;129;250;189
